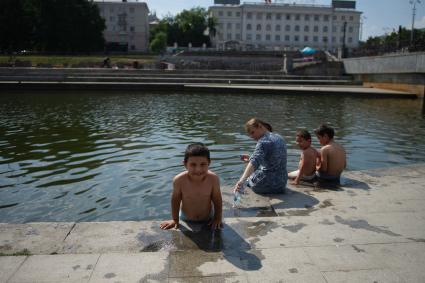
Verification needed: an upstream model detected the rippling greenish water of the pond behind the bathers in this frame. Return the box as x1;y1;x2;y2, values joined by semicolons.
0;92;425;223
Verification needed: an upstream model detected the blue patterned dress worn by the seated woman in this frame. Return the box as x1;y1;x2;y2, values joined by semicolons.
247;132;288;194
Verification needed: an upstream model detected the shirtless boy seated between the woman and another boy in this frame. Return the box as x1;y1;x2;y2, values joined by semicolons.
288;130;320;185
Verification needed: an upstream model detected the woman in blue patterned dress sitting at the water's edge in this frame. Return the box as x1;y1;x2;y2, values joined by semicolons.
234;118;288;194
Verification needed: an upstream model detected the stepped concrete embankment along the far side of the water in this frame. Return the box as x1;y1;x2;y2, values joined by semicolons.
0;68;416;98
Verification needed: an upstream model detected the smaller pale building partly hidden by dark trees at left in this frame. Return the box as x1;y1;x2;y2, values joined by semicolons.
95;0;149;52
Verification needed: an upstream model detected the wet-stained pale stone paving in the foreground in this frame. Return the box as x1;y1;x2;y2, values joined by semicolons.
0;164;425;283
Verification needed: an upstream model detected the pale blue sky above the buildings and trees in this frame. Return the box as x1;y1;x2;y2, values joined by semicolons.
98;0;425;40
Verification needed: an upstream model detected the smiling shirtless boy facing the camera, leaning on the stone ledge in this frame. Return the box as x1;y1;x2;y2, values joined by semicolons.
160;143;222;229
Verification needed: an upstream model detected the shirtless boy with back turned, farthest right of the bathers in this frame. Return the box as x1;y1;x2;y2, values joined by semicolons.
314;124;347;183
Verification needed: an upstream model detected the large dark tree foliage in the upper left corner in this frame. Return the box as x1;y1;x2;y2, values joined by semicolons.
0;0;105;53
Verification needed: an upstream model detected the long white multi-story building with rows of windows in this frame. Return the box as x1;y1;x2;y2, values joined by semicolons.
209;1;361;51
